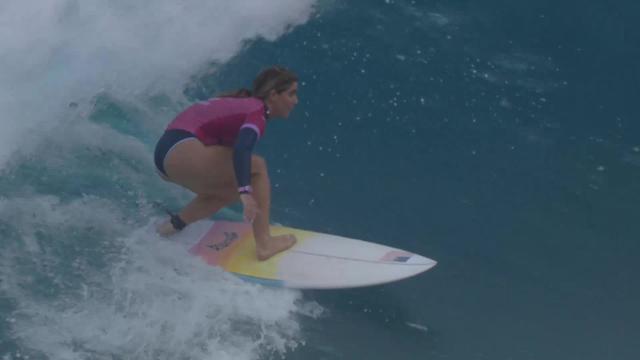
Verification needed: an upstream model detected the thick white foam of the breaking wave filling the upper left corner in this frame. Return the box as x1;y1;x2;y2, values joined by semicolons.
0;0;314;169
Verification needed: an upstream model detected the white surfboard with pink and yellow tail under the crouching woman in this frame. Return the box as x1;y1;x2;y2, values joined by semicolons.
189;220;436;289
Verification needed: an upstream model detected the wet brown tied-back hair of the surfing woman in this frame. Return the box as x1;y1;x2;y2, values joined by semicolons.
219;66;298;100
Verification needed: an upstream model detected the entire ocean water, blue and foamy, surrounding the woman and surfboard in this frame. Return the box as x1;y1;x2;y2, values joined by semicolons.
0;0;640;360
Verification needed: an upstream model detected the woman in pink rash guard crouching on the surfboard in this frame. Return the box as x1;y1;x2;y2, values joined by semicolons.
154;67;298;260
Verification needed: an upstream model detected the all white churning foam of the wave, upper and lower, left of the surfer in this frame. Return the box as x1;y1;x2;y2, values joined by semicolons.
0;0;322;359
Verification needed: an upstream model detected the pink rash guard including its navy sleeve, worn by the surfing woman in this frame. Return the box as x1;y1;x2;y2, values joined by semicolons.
166;97;268;192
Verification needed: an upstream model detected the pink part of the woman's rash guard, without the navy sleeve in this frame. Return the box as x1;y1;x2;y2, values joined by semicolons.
167;97;267;146
